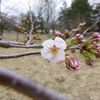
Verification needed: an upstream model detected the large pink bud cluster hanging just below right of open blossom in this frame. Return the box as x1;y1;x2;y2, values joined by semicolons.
65;57;80;70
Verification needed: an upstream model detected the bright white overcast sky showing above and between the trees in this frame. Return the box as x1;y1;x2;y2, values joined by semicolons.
1;0;100;14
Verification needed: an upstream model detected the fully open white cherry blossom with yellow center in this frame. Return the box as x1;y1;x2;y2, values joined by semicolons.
41;37;66;64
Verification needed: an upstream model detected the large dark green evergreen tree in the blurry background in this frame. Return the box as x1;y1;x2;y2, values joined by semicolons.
60;0;92;28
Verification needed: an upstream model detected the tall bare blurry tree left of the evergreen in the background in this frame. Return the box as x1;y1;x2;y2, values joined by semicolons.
43;0;59;34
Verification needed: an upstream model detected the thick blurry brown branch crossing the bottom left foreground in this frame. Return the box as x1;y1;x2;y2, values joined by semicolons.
0;67;68;100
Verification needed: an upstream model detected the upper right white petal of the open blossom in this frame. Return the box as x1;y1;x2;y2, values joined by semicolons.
54;37;66;49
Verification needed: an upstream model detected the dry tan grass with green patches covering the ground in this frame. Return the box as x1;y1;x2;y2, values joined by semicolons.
0;32;100;100
